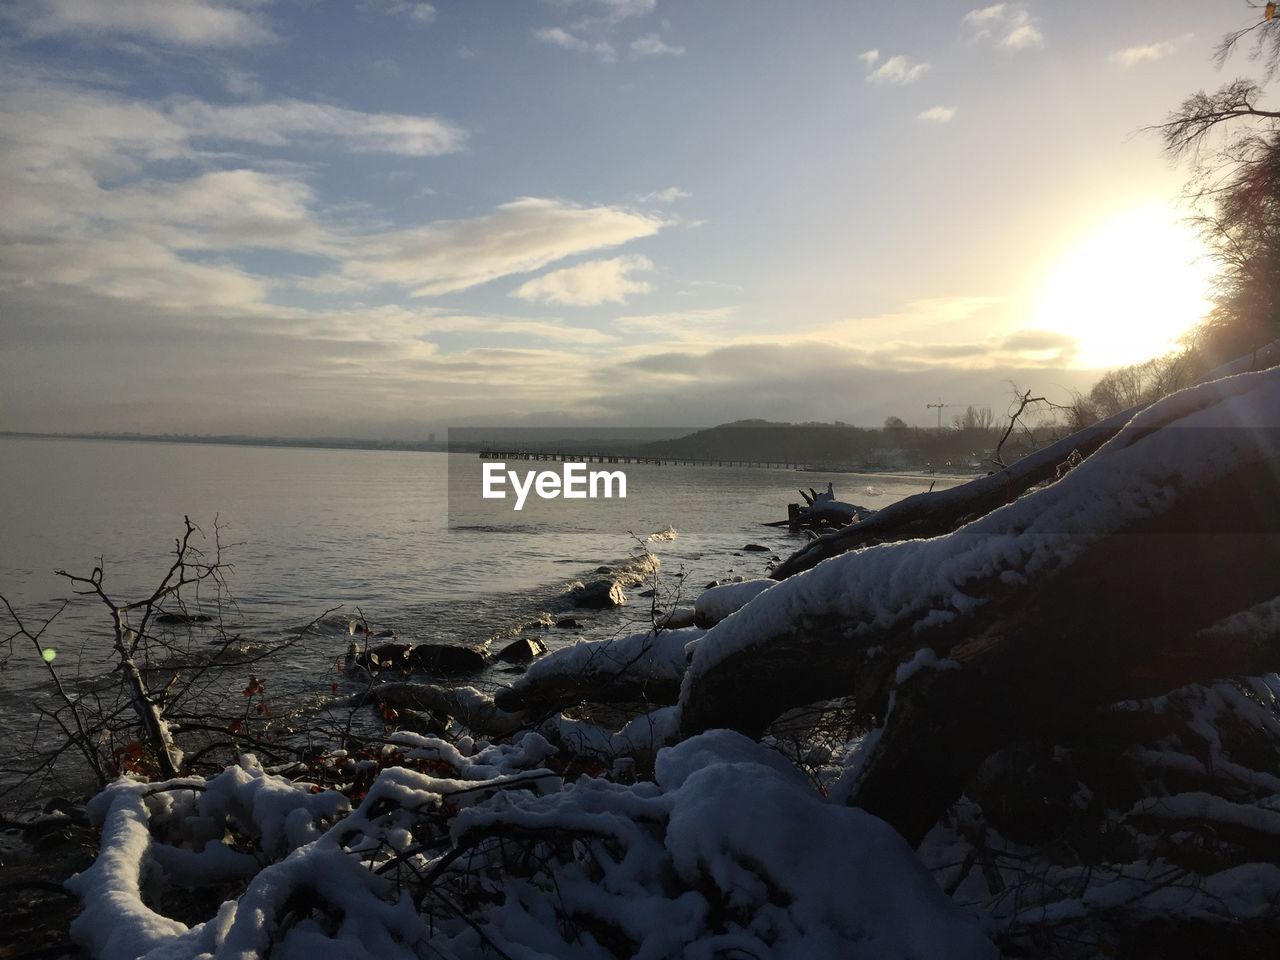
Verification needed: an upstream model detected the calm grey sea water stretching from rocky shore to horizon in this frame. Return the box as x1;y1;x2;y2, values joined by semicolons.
0;438;951;798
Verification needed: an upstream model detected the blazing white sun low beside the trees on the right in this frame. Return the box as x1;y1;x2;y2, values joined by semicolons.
1033;205;1213;369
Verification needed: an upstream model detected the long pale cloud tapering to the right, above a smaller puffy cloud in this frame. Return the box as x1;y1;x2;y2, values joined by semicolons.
346;197;666;297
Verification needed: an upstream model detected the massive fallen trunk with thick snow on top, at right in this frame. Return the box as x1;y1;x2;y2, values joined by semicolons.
680;371;1280;842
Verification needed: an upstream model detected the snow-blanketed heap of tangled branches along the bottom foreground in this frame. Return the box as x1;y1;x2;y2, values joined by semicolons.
72;731;995;960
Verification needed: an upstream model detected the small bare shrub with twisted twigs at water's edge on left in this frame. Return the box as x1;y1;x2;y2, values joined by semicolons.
0;517;318;792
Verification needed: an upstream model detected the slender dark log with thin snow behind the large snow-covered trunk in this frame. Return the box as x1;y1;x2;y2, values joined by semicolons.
769;340;1280;580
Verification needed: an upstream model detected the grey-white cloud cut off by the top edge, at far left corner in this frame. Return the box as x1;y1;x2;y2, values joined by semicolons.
9;0;274;47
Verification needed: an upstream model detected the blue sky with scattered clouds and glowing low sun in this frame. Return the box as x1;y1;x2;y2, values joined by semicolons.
0;0;1256;439
